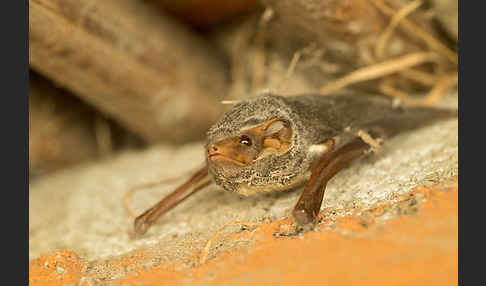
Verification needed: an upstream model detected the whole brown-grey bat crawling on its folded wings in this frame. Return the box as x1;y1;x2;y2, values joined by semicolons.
134;93;457;235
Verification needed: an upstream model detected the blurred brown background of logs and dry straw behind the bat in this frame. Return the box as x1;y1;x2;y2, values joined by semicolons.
29;0;458;179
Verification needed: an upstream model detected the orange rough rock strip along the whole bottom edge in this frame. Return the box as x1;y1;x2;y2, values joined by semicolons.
29;179;458;286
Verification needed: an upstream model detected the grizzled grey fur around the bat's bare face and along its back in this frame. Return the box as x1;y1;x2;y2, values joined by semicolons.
207;94;458;194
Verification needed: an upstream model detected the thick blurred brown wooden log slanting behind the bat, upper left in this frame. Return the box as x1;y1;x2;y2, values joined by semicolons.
29;0;227;142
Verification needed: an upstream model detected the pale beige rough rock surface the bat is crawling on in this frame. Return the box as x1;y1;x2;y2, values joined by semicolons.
29;93;458;285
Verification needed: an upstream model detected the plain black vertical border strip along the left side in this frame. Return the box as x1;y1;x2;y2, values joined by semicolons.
0;0;29;285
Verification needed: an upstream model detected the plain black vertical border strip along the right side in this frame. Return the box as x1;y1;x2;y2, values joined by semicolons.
458;0;486;285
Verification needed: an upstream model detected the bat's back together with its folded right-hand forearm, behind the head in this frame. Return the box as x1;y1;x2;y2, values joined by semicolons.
291;95;457;226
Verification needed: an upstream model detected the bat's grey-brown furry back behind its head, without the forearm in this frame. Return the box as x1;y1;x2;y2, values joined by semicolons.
286;94;457;145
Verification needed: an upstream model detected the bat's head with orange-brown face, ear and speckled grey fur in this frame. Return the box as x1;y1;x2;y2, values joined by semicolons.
206;94;307;195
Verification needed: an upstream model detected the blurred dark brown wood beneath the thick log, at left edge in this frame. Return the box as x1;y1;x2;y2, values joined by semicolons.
29;72;102;176
